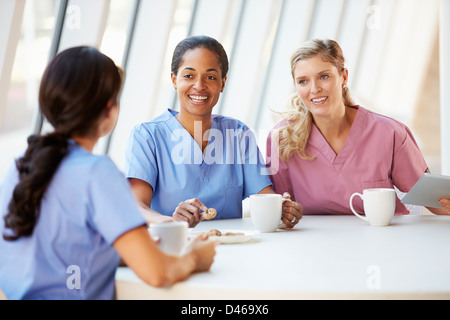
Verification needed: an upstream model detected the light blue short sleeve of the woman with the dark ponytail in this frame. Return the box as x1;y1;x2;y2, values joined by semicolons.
88;157;146;244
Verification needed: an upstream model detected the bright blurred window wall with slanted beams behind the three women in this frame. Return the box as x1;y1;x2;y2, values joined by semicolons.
0;0;446;180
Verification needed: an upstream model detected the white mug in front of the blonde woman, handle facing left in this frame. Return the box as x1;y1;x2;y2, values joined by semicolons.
350;188;396;227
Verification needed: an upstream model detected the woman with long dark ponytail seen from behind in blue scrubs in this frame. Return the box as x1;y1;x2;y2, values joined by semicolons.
0;47;216;299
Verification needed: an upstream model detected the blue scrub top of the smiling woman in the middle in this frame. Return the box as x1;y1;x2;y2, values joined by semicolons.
125;109;271;219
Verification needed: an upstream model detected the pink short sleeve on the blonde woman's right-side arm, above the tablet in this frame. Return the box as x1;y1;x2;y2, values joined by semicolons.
392;127;428;192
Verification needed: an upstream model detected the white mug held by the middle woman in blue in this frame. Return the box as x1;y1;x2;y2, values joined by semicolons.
250;193;287;232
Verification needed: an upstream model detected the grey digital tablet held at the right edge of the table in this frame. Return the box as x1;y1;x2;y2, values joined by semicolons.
402;173;450;208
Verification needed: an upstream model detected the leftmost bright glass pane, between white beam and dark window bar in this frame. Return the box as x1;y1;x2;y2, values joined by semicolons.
0;0;58;178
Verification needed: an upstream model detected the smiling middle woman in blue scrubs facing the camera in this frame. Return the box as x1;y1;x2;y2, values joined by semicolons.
125;36;302;228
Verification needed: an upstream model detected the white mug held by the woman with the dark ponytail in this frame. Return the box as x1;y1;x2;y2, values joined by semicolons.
148;221;188;256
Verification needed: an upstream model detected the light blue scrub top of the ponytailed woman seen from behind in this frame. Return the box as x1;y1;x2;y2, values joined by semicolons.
0;142;145;300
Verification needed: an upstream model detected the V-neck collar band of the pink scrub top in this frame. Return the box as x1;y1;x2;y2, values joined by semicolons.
308;106;367;171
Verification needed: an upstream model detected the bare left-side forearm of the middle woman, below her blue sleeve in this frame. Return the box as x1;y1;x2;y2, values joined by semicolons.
128;178;173;224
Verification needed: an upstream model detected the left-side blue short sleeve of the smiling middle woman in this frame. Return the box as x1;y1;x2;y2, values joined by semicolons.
124;125;158;189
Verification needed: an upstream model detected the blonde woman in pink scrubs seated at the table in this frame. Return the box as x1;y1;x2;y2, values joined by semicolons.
267;40;449;214
